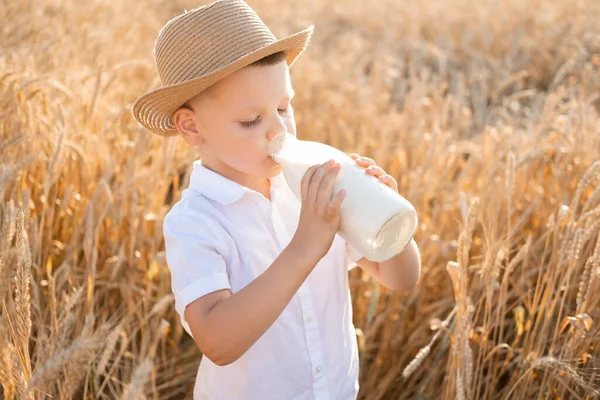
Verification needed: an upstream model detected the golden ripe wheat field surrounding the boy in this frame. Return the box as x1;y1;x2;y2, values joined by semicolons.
0;0;600;400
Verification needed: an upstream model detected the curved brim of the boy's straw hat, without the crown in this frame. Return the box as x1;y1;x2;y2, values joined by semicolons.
132;25;314;136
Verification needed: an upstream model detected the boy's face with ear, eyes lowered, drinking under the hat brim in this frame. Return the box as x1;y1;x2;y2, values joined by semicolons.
173;61;296;187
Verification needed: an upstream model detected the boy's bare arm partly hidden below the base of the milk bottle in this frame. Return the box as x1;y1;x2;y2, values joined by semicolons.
356;239;421;292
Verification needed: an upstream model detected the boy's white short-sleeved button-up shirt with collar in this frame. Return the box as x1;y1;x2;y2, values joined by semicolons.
163;160;362;400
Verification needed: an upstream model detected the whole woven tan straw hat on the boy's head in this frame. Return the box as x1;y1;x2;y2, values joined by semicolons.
133;0;313;136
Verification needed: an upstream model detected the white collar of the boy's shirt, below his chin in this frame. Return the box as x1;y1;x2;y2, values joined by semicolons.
190;160;285;204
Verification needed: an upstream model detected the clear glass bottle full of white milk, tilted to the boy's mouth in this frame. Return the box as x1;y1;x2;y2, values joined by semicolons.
268;133;418;262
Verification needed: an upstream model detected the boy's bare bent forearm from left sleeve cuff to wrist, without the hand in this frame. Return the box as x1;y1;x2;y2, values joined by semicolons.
185;243;318;365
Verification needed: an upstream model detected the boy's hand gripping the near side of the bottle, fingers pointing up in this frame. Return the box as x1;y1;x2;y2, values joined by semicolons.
291;160;346;263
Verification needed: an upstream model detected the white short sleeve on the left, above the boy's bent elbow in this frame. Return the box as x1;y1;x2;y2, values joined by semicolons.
163;214;231;336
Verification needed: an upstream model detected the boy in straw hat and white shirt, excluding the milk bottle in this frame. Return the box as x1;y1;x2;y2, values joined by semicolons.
133;0;420;400
